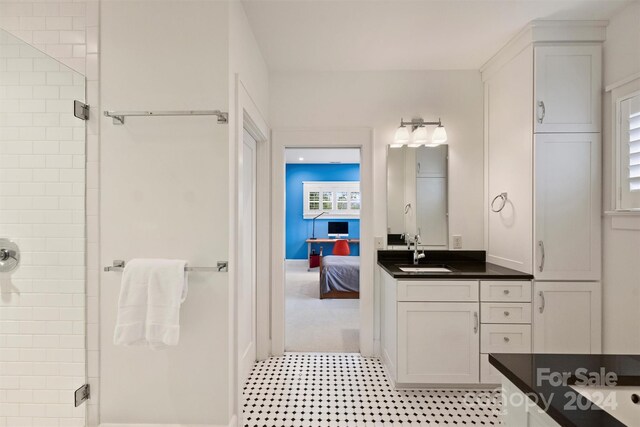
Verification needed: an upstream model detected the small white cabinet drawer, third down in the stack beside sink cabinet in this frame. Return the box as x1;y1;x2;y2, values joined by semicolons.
480;325;531;353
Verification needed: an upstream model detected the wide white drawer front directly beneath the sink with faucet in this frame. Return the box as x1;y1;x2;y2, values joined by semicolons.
398;280;478;302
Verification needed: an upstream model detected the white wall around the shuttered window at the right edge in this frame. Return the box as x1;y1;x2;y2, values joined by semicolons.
603;1;640;354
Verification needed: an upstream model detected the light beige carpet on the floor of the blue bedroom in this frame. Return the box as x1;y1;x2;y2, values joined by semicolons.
284;260;360;353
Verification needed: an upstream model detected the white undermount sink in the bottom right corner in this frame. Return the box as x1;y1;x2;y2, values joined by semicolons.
571;385;640;426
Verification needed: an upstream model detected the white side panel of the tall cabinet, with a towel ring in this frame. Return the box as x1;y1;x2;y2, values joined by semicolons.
484;48;533;273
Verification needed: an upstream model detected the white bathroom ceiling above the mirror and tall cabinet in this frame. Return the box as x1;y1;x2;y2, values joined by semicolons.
243;0;631;71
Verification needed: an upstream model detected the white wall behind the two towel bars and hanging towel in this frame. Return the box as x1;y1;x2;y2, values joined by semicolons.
100;1;231;425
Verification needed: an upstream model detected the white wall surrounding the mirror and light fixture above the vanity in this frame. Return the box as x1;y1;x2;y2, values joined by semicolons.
269;71;484;249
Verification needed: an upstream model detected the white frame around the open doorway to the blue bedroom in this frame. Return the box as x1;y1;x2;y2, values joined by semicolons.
271;128;374;356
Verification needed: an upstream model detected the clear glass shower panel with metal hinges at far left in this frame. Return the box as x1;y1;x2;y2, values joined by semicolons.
0;30;86;427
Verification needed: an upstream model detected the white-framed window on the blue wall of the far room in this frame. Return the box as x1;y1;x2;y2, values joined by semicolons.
302;181;360;219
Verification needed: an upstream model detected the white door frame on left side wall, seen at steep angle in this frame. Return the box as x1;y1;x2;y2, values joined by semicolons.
229;75;271;425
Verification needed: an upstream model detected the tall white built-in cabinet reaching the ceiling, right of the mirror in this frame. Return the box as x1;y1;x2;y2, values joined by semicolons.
481;21;605;353
